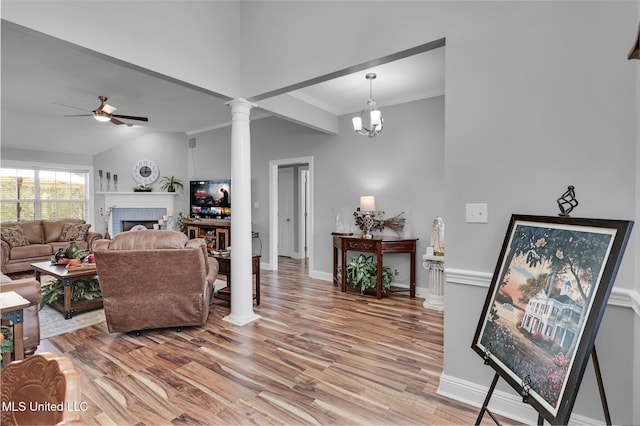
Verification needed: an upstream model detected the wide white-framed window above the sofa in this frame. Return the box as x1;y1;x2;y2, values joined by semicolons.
0;168;89;222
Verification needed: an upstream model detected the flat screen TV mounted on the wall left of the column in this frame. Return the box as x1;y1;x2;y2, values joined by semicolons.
190;179;231;219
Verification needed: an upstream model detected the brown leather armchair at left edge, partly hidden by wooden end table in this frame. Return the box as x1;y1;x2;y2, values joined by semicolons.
0;274;42;357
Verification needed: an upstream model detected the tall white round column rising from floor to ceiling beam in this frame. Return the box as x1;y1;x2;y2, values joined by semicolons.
223;98;260;325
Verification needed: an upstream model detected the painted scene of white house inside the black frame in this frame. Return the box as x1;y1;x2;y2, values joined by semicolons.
476;221;615;415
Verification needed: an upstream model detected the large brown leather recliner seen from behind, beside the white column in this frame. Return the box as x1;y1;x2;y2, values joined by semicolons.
93;230;218;333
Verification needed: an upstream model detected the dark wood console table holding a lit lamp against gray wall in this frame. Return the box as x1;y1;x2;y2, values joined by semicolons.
333;234;418;299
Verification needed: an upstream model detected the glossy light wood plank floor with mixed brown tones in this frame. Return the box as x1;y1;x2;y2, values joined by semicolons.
38;258;510;425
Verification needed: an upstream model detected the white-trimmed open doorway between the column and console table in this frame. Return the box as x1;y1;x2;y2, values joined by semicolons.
269;157;313;271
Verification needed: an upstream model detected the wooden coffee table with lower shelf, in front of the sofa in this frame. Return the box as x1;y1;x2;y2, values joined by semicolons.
31;262;102;319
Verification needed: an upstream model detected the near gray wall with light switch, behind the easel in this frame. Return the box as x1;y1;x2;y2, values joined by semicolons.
445;2;639;424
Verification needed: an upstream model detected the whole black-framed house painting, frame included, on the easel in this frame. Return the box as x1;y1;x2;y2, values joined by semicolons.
471;215;633;424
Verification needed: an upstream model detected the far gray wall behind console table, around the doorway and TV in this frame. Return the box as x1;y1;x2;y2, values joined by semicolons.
189;96;446;289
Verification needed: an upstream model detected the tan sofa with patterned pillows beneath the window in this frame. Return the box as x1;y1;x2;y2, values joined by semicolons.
0;219;102;274
